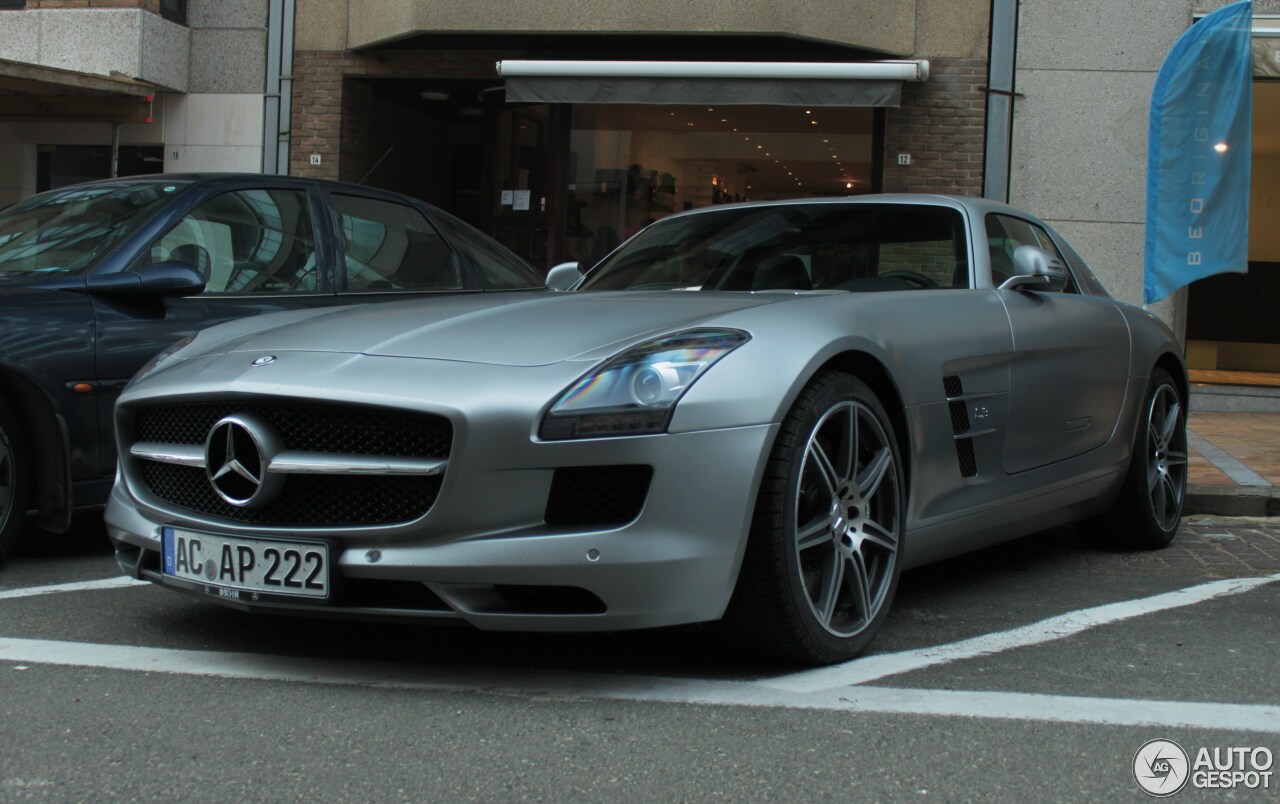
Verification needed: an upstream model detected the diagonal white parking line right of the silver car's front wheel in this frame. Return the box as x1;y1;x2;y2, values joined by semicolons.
764;574;1280;693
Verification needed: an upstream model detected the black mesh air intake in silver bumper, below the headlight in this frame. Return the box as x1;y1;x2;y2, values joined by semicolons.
545;466;653;527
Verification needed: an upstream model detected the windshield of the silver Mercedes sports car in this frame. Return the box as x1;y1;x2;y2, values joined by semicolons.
579;204;969;292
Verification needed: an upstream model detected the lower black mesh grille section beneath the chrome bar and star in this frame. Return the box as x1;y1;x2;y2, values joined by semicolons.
142;461;442;527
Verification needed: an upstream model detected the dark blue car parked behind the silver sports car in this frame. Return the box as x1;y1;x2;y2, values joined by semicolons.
0;174;541;561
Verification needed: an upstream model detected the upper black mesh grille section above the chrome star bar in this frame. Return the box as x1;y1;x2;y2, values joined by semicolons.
136;402;453;458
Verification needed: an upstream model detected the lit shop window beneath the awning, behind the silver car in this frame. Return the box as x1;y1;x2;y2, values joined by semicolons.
564;104;874;264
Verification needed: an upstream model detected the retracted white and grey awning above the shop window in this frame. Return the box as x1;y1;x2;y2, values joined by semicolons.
498;60;929;106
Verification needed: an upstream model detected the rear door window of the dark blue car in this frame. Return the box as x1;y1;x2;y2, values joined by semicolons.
332;195;462;291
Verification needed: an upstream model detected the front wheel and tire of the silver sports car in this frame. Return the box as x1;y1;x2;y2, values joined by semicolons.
726;373;906;664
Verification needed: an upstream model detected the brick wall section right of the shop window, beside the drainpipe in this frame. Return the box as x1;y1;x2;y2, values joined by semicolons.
884;59;987;196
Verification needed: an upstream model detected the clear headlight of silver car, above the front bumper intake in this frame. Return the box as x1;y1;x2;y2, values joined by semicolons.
539;329;750;440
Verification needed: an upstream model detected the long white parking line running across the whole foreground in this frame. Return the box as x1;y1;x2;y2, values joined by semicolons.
0;638;1280;734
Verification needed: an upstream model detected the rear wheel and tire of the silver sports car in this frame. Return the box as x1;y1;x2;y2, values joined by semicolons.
1101;369;1187;551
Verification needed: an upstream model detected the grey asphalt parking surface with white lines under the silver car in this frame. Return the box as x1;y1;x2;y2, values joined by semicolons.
0;516;1280;801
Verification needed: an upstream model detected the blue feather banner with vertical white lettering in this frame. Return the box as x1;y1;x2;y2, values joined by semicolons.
1143;3;1253;303
